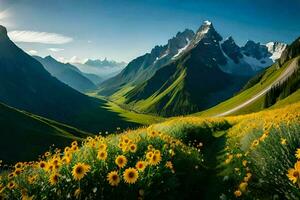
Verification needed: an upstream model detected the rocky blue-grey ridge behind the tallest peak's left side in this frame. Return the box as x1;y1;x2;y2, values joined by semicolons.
100;29;195;95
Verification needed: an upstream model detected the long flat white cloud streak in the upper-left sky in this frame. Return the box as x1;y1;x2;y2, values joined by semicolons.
8;31;73;44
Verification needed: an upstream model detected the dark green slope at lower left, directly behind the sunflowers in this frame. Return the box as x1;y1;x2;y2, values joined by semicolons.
0;103;90;162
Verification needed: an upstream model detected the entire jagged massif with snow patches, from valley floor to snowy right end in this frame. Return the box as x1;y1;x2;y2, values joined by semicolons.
99;21;286;116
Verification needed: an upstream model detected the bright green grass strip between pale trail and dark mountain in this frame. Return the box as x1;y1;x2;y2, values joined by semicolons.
193;60;292;117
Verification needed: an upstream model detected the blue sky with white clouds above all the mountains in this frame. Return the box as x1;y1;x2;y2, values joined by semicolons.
0;0;300;62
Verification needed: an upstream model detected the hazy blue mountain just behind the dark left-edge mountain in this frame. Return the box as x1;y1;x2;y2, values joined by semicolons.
34;56;96;93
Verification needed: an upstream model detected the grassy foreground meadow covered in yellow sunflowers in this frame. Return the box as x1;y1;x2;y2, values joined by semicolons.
0;103;300;199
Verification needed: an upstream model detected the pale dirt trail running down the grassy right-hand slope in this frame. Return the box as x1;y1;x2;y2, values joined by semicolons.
214;58;299;117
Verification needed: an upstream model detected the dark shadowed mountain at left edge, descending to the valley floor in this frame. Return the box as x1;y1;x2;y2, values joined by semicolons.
0;26;132;133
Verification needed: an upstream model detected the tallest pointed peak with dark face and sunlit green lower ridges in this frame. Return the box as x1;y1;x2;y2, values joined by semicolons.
125;21;248;116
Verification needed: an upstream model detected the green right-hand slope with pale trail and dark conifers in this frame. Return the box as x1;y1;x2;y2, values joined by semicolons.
197;38;300;116
